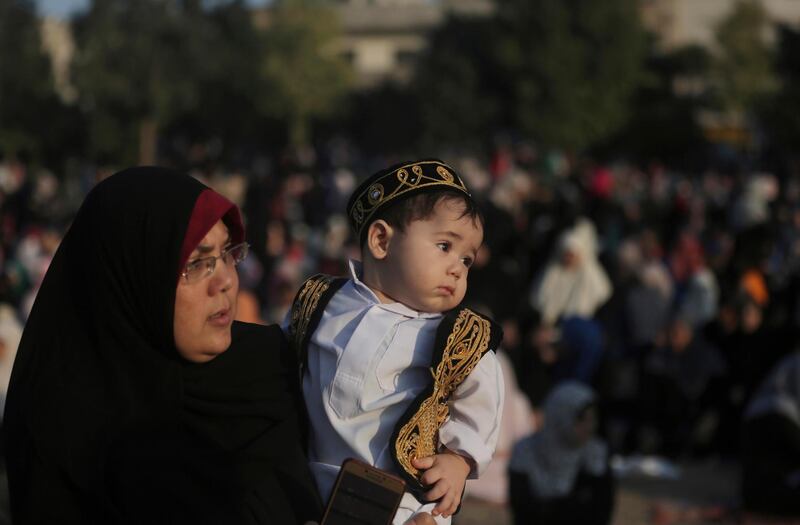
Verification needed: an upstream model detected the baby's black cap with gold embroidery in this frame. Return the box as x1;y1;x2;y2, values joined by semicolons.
347;159;472;238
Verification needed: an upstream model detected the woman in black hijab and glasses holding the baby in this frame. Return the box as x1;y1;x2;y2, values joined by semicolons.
5;167;321;524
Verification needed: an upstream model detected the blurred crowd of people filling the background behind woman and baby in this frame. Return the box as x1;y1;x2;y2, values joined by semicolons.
0;144;800;520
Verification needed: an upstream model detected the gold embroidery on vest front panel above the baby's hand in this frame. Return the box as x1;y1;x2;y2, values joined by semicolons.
395;308;491;479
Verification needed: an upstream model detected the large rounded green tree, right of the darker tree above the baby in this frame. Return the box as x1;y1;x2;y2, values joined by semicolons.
494;0;645;150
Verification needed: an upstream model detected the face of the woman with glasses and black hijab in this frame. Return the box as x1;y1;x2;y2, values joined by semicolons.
173;220;239;363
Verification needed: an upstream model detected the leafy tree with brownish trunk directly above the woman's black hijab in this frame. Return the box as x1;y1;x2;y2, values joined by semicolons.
73;0;233;164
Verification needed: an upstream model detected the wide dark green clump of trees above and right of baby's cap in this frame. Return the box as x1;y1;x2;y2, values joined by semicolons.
416;0;645;150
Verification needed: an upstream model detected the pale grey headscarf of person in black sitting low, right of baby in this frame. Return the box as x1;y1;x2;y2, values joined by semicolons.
508;381;608;498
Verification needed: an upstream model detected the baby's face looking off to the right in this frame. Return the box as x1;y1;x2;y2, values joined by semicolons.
382;200;483;312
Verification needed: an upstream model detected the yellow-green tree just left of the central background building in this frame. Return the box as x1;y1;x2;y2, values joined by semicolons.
260;0;351;146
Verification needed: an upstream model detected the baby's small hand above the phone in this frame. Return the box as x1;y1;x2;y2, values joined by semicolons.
411;449;472;518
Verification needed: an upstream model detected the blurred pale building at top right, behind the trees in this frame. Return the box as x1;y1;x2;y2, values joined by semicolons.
640;0;800;51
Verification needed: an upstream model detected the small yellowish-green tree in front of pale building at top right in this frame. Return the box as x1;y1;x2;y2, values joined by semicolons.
713;0;776;113
